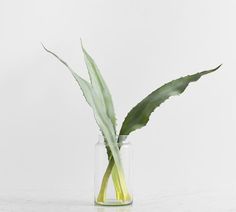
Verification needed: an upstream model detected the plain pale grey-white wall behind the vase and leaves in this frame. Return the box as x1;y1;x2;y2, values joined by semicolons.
0;0;236;210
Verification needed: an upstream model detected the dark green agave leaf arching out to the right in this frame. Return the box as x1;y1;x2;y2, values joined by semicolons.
119;65;221;142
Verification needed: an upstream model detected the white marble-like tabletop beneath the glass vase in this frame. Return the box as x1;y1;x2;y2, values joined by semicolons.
0;186;236;212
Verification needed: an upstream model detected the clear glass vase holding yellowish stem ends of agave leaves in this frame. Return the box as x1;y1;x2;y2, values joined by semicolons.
94;136;133;206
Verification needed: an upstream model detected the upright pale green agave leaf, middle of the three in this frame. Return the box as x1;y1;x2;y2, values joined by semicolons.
81;41;116;130
